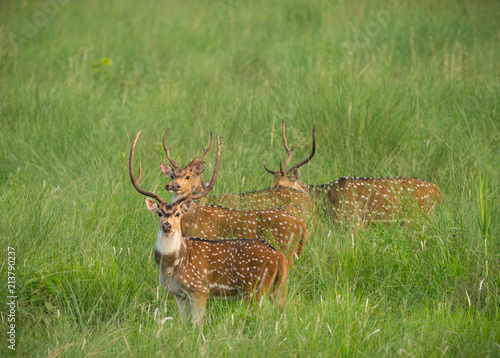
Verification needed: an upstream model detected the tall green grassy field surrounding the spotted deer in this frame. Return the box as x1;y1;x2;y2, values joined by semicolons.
0;0;500;357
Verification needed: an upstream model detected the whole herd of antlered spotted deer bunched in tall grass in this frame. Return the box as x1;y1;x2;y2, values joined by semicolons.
129;123;442;326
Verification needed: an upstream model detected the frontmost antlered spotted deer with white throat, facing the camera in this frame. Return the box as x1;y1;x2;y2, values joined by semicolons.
129;131;288;326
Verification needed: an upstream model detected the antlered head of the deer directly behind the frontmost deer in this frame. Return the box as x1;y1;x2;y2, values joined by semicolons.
160;128;213;201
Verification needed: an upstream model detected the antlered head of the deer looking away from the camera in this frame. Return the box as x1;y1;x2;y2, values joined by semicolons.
262;121;316;190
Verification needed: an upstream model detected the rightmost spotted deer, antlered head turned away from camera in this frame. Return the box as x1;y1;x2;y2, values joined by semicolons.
263;122;442;226
